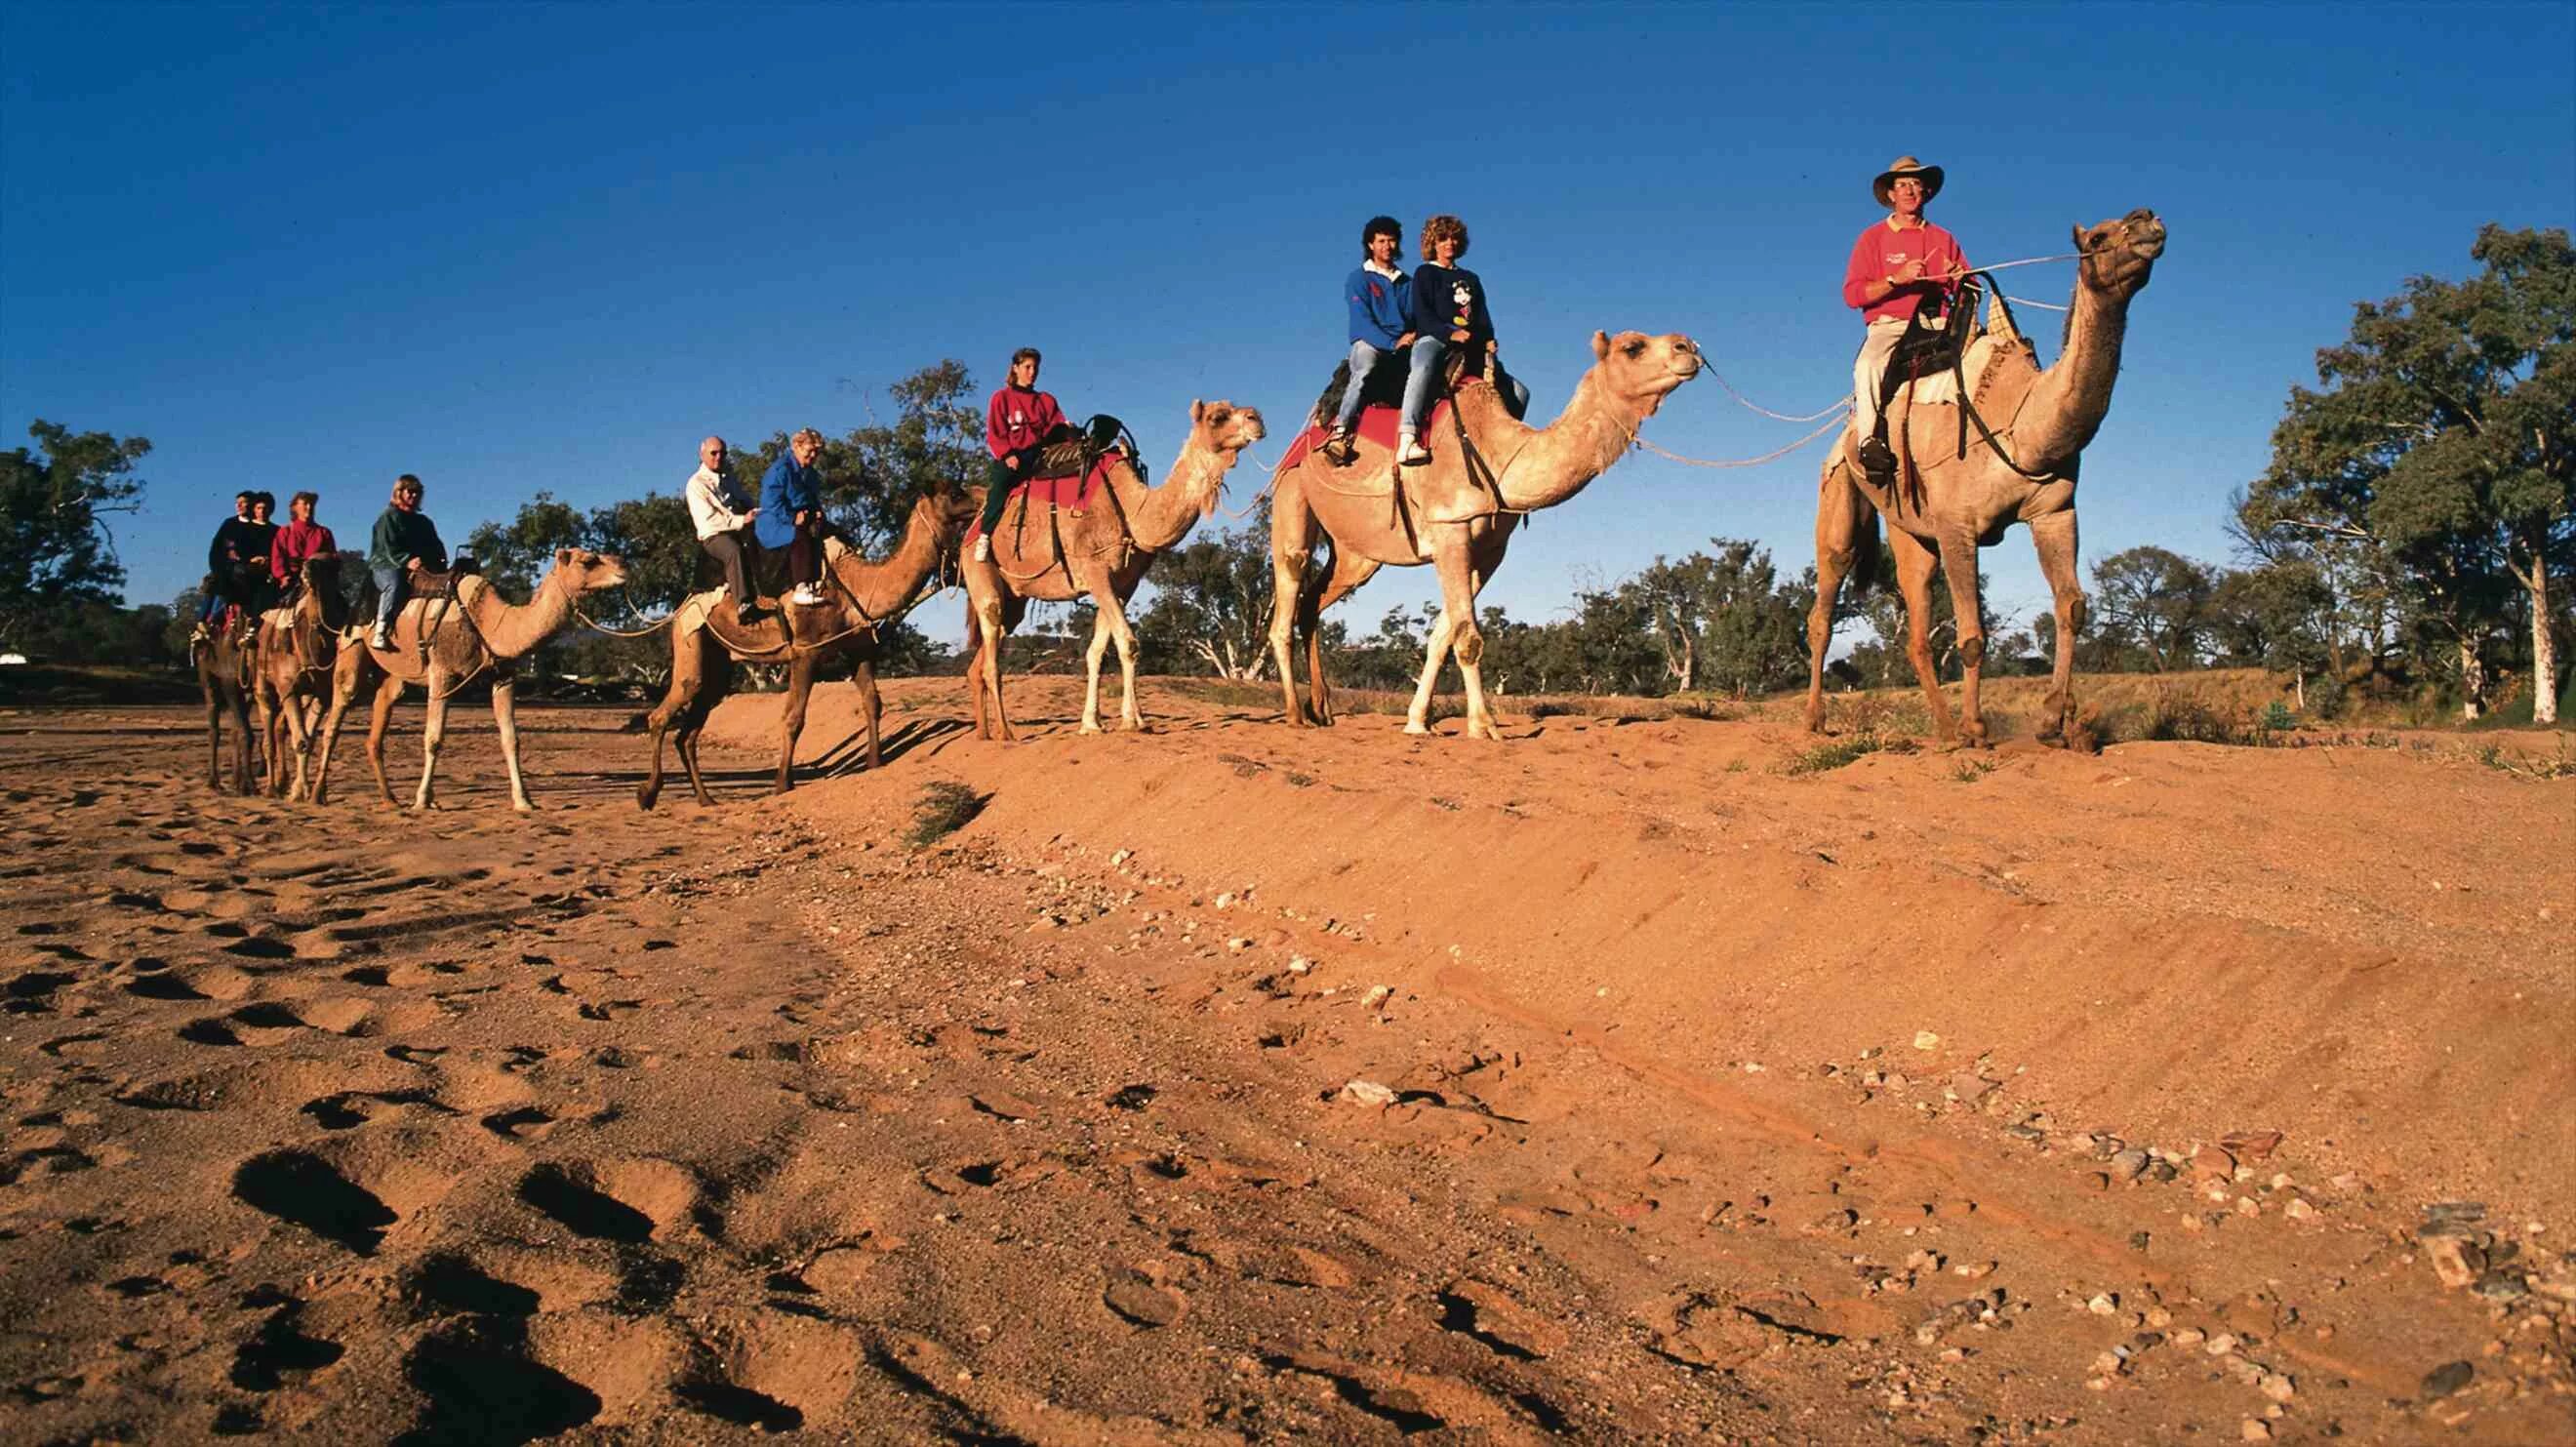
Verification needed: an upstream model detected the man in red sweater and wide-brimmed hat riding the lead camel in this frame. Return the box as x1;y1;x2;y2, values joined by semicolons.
1842;157;1968;487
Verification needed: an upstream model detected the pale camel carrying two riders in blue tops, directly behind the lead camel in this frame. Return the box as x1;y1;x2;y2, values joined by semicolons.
1270;332;1703;739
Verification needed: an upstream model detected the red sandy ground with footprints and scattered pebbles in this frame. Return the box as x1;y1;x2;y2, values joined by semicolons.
0;680;2576;1442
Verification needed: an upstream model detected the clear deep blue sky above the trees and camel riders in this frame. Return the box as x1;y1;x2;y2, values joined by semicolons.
0;0;2576;638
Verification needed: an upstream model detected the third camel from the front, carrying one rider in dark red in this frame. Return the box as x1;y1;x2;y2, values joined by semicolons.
963;402;1265;742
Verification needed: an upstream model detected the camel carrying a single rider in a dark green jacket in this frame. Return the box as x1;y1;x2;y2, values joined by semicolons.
314;548;626;814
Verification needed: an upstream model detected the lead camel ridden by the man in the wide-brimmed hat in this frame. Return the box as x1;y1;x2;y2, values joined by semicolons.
1806;209;2164;746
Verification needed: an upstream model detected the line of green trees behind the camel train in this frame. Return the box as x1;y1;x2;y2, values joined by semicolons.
0;224;2576;724
